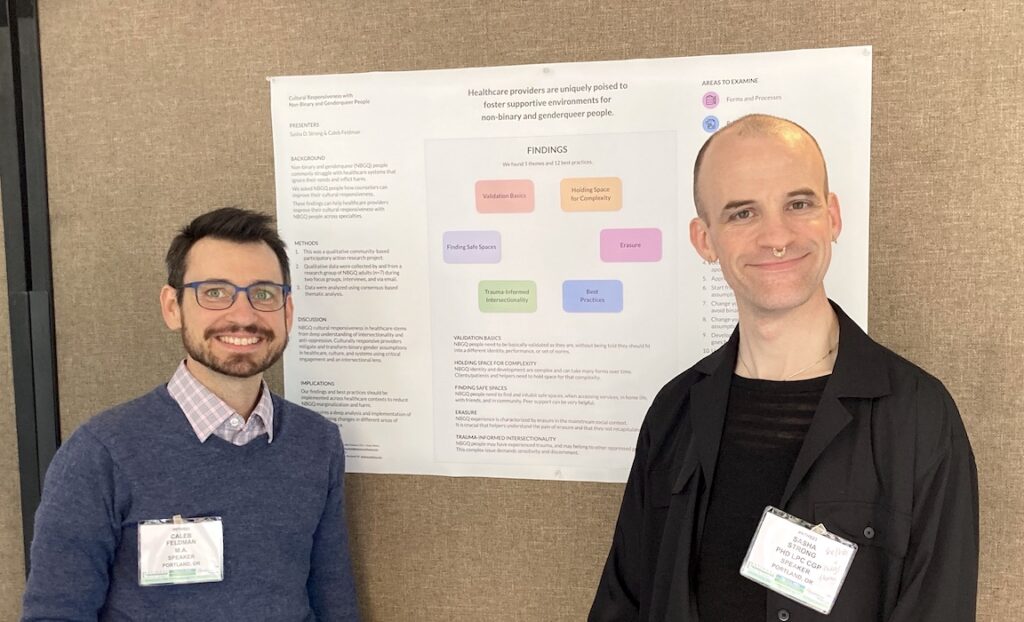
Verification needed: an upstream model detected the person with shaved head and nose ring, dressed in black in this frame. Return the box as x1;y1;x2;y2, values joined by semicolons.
589;115;978;622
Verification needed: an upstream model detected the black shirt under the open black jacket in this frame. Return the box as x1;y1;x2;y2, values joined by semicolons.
696;375;828;622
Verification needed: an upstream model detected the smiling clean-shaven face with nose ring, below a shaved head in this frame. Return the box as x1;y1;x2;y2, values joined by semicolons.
690;125;842;316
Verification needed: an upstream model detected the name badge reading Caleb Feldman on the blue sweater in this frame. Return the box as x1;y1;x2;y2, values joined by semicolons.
138;515;224;587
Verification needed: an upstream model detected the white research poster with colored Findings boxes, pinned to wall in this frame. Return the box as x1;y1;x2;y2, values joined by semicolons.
270;47;871;482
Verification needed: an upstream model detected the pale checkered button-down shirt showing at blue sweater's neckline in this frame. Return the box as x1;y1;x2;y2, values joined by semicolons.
167;361;273;446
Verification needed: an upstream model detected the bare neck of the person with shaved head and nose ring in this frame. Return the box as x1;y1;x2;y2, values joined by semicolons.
736;291;839;380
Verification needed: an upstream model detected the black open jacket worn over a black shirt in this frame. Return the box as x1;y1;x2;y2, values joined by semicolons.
589;304;978;622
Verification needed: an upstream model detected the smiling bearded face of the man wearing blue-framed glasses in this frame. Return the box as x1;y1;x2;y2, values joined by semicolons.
161;238;292;386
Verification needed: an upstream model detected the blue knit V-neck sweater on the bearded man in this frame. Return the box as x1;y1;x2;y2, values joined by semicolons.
24;386;358;622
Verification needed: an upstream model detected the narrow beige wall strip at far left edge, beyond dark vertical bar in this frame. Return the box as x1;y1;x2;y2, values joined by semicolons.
0;192;25;620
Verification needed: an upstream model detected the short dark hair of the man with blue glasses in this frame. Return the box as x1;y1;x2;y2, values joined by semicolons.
166;207;292;298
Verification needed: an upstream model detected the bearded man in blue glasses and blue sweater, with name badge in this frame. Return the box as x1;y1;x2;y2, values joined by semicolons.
23;208;358;621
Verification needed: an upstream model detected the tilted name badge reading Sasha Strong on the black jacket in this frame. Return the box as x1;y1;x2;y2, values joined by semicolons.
739;505;857;616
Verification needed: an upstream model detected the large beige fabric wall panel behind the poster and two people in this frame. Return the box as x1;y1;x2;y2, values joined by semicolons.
19;0;1024;622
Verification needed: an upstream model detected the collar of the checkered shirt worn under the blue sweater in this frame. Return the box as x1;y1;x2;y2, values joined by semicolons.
167;361;273;443
